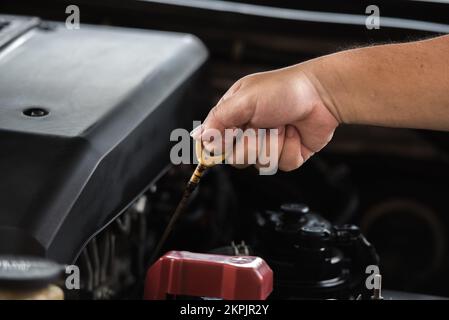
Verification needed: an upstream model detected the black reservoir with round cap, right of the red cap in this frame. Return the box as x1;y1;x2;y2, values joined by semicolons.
255;203;379;299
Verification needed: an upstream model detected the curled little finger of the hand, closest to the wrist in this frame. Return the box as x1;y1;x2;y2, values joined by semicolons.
279;125;304;171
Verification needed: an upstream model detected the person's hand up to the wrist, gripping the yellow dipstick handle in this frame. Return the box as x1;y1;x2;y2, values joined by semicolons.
193;65;338;171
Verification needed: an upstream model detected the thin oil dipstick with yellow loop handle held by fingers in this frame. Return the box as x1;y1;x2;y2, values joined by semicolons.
150;140;225;263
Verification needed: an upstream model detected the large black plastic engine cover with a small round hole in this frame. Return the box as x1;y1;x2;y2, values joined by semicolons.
0;16;207;263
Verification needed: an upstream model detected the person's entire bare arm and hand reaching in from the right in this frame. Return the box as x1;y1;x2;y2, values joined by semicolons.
192;36;449;171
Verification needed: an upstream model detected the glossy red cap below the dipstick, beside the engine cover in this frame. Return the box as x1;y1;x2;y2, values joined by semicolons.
144;251;273;300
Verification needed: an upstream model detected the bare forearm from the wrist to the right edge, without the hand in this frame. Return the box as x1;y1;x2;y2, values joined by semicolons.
295;36;449;130
